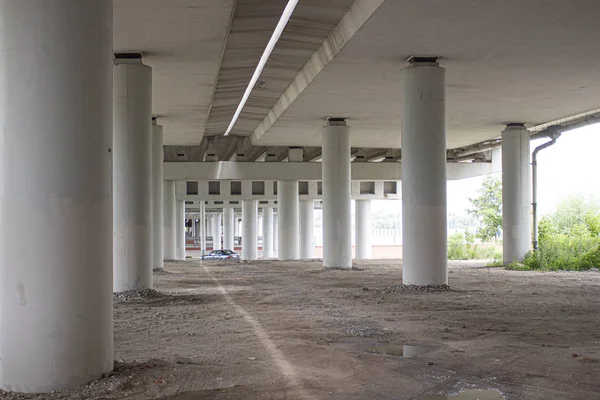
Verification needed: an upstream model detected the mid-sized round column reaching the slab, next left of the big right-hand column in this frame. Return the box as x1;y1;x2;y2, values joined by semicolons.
322;119;352;269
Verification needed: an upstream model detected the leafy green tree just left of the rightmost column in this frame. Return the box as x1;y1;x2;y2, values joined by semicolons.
468;176;502;242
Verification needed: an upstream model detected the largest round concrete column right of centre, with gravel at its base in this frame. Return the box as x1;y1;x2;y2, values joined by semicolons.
401;60;448;286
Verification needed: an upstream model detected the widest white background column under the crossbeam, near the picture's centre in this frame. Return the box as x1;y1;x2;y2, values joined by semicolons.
277;181;300;260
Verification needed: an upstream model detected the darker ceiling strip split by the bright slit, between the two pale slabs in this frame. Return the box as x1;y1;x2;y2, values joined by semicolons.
205;0;354;136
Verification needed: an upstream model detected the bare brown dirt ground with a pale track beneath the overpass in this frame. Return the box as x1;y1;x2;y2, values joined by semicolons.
0;260;600;400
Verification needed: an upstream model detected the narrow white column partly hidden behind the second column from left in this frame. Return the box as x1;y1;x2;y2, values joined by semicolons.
152;125;165;270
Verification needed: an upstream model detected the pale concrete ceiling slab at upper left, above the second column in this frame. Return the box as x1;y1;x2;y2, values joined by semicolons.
114;0;235;145
